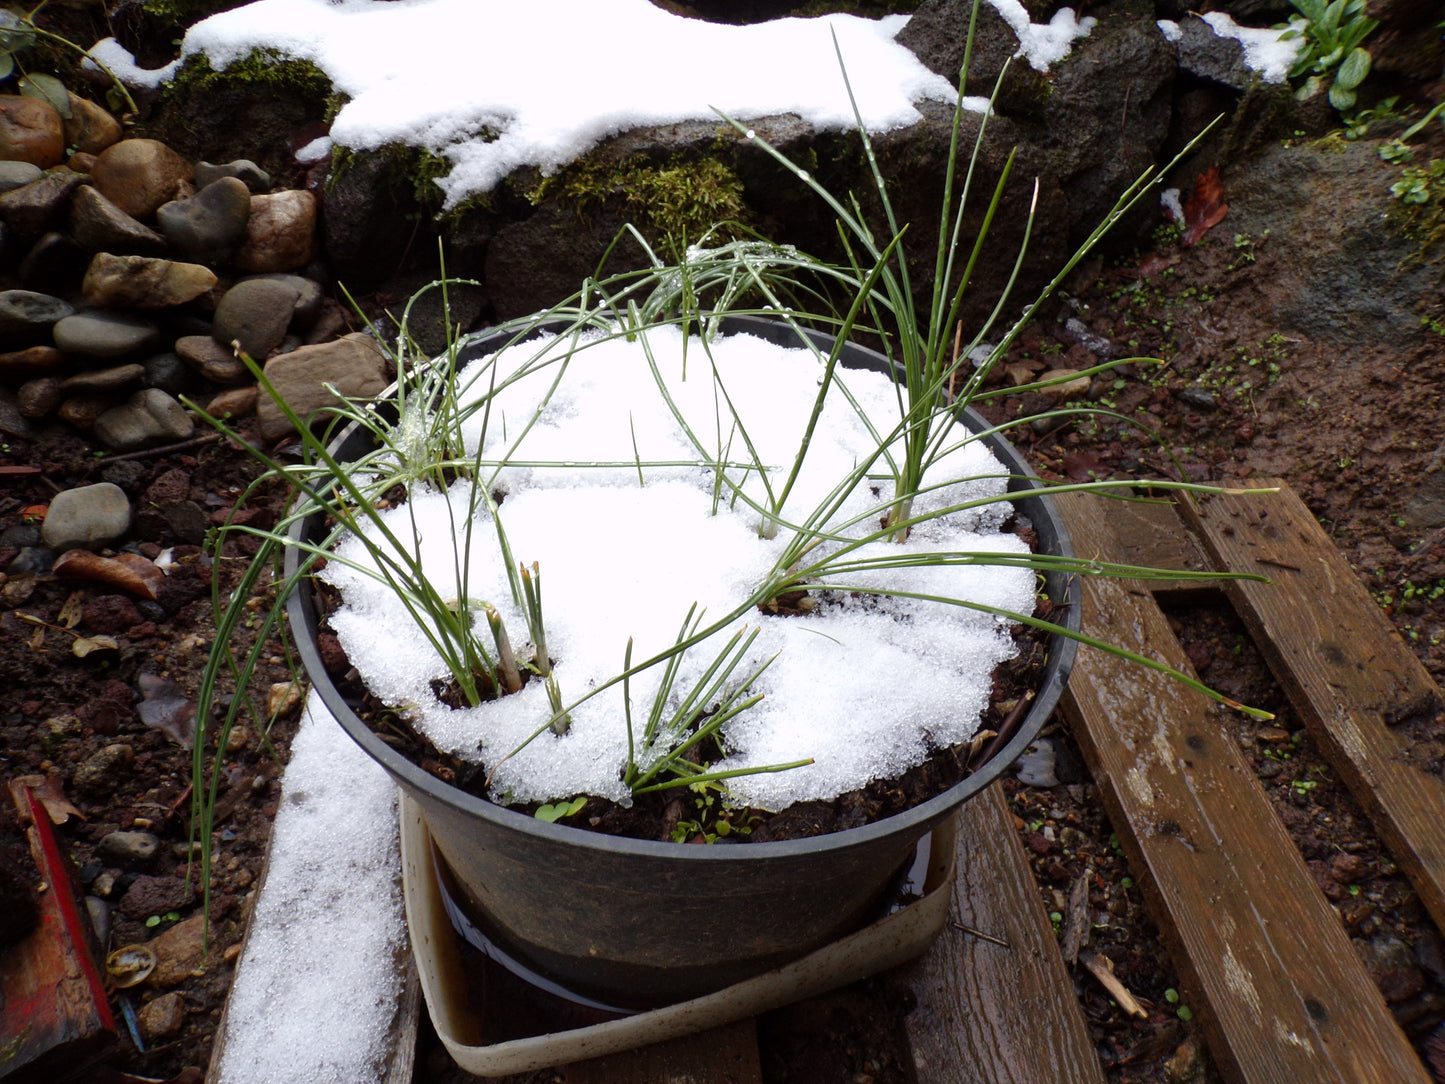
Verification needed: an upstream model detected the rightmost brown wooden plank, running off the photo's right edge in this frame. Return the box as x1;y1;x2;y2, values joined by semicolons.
1186;478;1445;928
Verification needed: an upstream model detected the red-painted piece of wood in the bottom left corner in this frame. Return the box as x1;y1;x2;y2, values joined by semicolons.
0;782;116;1084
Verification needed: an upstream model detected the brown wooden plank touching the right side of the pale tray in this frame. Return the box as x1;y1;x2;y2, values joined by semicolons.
896;783;1104;1084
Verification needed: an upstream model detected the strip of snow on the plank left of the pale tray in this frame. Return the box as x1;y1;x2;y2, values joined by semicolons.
214;692;410;1084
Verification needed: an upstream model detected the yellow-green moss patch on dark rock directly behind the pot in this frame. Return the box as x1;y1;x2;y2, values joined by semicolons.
527;155;749;250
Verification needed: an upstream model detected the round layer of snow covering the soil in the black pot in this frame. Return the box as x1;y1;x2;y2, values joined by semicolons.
324;325;1036;809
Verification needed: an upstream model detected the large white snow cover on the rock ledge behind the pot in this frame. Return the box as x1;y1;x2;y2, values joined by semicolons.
94;0;1094;205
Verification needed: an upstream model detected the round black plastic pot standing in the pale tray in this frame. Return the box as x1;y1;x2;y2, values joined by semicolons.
288;317;1079;1007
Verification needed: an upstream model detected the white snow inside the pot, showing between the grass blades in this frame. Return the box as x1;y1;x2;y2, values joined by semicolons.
325;328;1035;808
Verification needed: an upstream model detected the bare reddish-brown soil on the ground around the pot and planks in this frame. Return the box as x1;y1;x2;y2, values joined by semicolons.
0;161;1445;1084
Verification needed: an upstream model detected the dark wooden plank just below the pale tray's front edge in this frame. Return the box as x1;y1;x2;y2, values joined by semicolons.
562;1018;763;1084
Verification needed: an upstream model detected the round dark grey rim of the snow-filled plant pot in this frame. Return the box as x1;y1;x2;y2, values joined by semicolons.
285;315;1081;863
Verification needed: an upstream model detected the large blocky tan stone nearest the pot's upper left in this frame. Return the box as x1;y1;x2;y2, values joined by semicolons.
256;332;390;439
